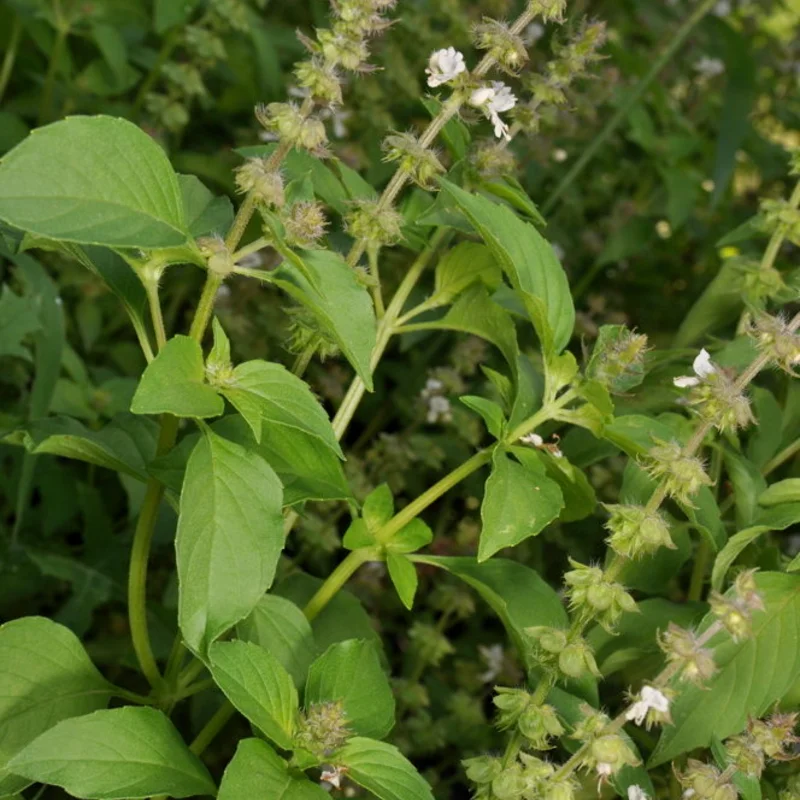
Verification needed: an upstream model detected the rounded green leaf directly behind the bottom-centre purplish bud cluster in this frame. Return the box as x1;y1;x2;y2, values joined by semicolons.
305;639;394;739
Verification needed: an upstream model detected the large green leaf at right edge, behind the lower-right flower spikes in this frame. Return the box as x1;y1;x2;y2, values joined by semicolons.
649;572;800;767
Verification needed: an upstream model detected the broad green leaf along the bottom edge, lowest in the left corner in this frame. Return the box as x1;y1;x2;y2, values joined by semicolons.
10;706;216;800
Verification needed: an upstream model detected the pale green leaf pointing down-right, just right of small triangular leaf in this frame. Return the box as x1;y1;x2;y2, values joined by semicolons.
220;361;344;458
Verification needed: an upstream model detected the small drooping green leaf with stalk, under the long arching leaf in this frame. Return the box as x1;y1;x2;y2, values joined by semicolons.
403;286;519;372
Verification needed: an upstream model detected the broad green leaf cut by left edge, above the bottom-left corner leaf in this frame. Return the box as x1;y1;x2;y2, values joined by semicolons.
0;617;111;796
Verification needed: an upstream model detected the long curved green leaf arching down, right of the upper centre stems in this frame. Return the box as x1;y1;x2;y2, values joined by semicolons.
442;180;575;353
